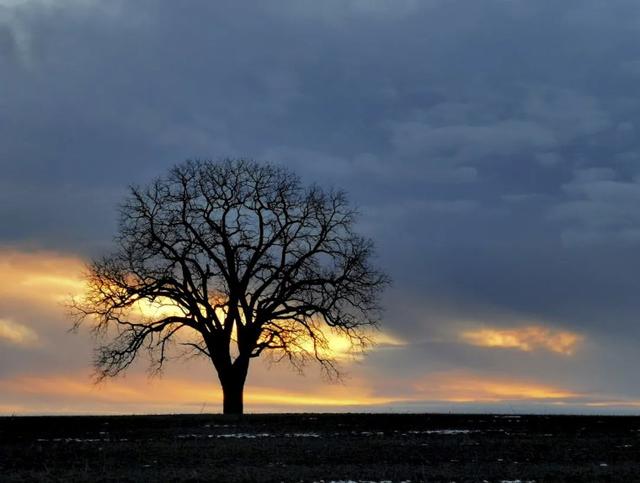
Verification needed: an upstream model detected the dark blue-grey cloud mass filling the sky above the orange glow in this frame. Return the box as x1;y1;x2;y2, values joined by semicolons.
0;0;640;410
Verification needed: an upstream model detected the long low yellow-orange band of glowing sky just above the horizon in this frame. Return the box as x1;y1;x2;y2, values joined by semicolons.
0;371;580;412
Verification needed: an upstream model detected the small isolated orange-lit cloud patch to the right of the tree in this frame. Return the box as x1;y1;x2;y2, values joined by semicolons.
460;325;582;355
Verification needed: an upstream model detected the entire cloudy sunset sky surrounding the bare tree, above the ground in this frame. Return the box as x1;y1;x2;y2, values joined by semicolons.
0;0;640;414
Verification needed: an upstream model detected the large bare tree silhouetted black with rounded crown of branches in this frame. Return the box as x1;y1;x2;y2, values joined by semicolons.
71;160;388;414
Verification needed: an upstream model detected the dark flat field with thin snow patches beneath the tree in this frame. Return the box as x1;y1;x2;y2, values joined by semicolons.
0;414;640;483
